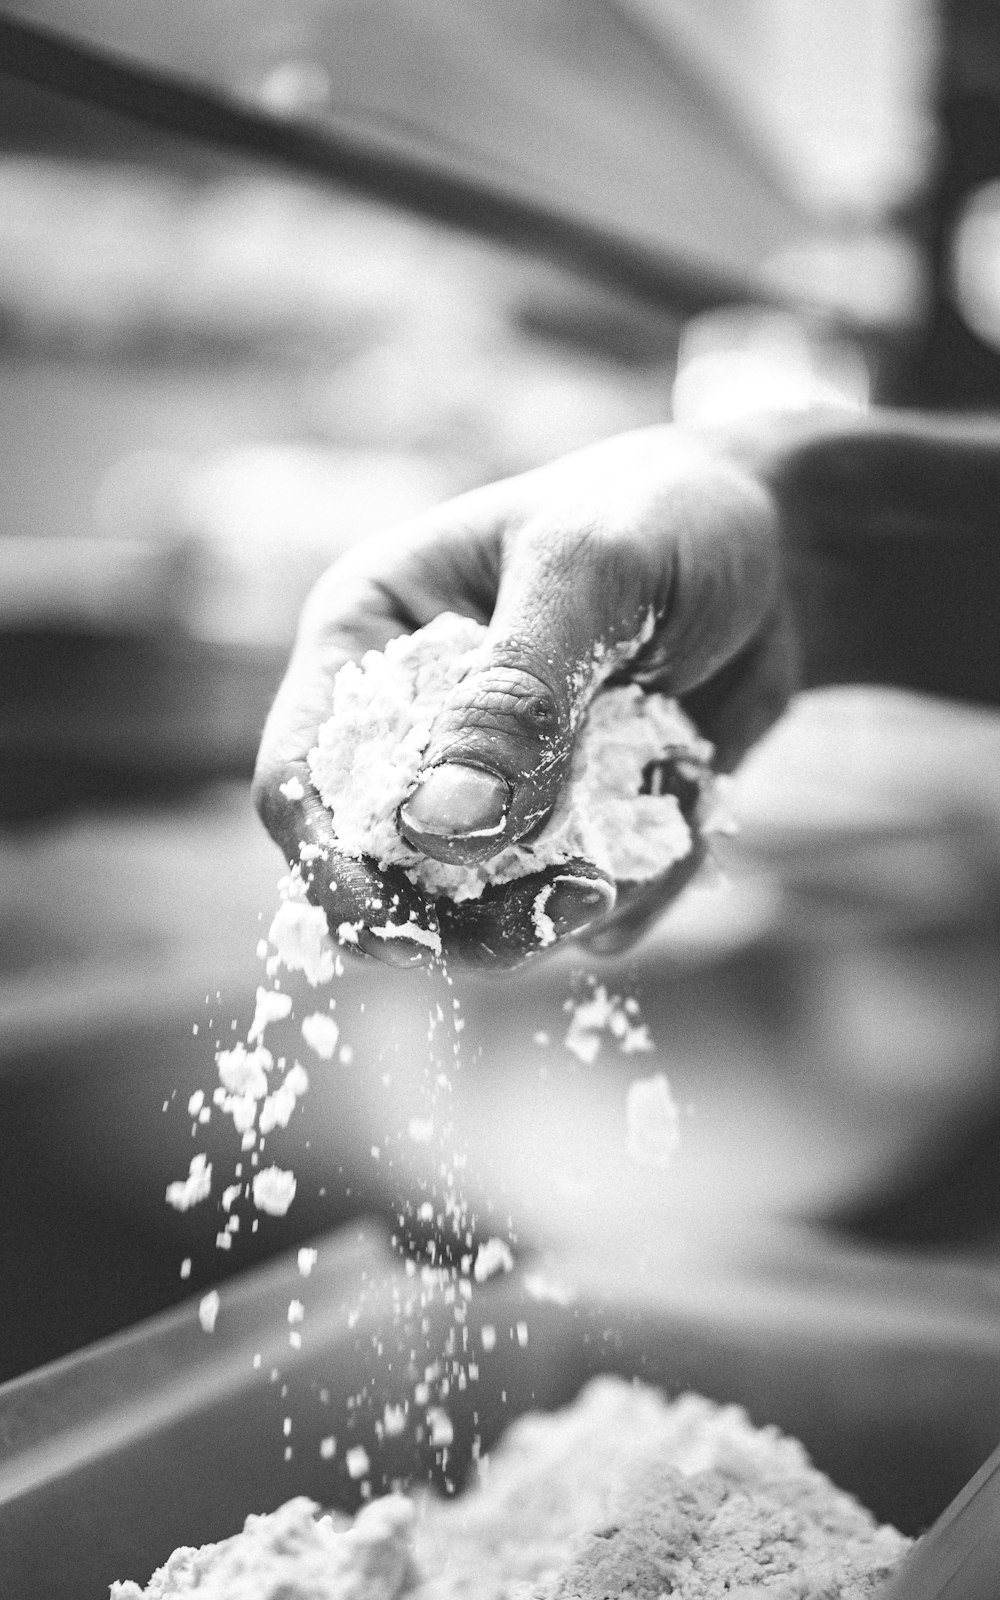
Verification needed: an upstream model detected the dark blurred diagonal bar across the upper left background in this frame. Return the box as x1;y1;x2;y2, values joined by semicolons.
0;14;781;315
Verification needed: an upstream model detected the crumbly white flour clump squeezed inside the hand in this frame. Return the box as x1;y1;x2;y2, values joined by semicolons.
309;613;714;901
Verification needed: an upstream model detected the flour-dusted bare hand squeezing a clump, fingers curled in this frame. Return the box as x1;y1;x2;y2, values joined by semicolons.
254;427;792;965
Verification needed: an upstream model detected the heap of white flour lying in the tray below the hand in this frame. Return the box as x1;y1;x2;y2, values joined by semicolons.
112;1378;909;1600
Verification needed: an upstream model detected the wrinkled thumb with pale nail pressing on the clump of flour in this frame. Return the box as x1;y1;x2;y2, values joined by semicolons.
400;520;659;862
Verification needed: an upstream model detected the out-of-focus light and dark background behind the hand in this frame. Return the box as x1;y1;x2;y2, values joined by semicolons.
0;0;1000;1378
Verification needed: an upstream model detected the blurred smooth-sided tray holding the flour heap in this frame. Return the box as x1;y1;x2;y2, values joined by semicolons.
0;1227;1000;1600
